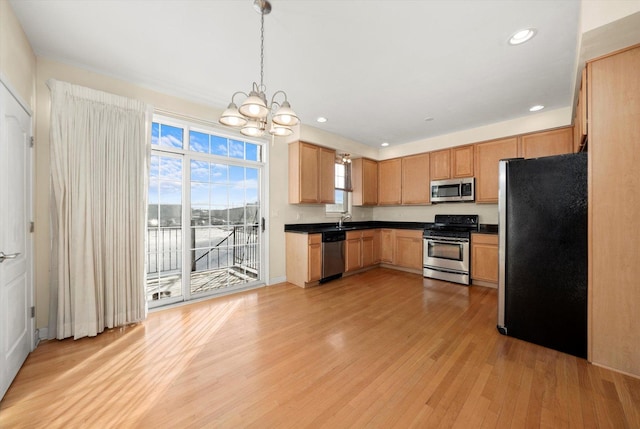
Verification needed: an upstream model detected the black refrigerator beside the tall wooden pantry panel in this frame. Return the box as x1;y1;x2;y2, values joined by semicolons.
498;153;587;358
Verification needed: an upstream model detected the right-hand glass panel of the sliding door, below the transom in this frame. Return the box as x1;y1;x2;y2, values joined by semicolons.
190;160;261;295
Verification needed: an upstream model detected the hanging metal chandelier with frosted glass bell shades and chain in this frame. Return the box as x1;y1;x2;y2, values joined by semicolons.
219;0;300;137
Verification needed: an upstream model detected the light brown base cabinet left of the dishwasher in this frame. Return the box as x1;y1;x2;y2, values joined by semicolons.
285;232;322;287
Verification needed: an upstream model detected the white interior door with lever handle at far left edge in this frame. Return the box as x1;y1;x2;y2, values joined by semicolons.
0;83;33;399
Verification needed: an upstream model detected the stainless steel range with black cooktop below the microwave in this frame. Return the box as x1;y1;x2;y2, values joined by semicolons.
422;215;479;285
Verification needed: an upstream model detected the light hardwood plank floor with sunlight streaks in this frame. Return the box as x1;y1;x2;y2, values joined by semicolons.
0;269;640;429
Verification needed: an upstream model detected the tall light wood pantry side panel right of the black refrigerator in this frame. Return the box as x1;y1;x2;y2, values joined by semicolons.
583;45;640;377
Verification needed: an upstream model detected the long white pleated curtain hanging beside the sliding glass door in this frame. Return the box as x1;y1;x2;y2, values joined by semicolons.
47;80;150;339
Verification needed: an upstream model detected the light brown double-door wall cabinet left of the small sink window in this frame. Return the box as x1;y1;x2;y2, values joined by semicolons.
289;141;336;204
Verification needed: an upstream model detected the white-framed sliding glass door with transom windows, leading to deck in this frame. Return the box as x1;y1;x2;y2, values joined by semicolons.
147;115;264;307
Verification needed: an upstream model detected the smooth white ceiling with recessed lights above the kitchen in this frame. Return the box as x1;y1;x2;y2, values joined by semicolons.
10;0;580;146
